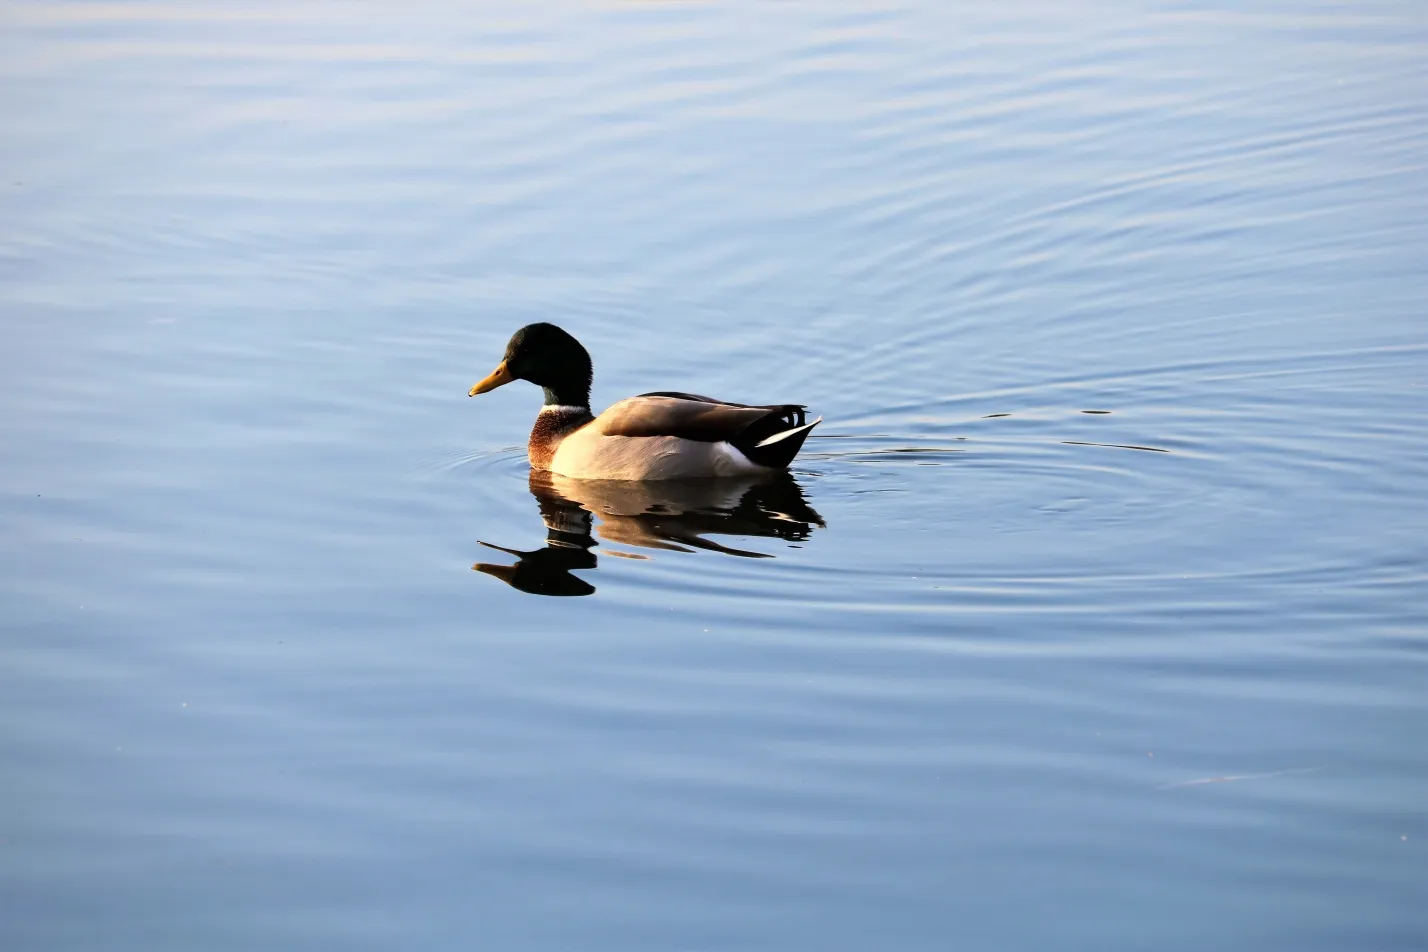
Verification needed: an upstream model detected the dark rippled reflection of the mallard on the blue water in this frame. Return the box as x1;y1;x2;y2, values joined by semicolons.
471;471;824;595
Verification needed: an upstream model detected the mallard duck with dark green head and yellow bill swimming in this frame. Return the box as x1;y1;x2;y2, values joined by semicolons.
468;323;823;480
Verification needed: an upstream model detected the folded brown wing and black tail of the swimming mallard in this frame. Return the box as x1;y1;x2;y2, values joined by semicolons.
591;391;818;467
